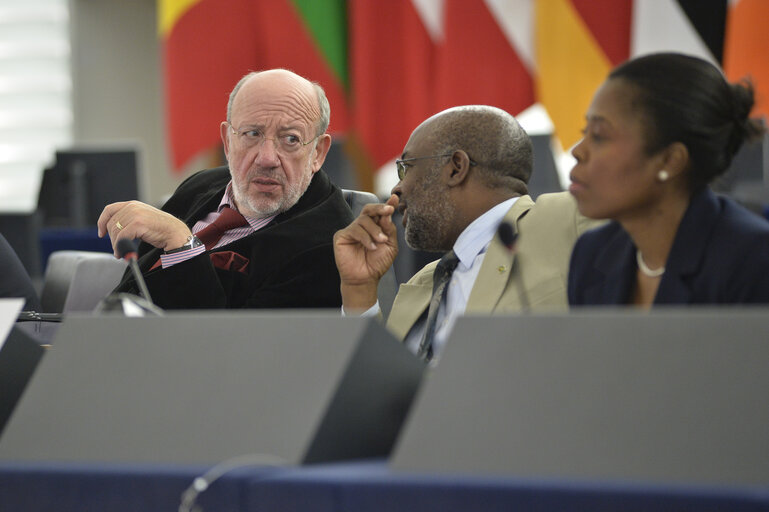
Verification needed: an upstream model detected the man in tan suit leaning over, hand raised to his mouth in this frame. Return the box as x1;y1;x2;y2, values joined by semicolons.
334;106;590;359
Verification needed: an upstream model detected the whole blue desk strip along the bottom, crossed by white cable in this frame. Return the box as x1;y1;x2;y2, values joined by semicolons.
0;462;769;512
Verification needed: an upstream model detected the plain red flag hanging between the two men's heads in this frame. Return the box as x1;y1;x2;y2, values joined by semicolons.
349;0;435;190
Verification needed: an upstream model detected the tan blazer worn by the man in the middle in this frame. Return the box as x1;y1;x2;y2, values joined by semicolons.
387;192;598;340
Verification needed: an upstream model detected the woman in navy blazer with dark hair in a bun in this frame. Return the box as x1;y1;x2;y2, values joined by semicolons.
568;53;769;308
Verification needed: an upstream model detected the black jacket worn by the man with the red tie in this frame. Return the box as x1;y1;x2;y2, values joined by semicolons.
116;167;353;309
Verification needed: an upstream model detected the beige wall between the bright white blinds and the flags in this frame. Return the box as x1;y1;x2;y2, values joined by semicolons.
70;0;192;203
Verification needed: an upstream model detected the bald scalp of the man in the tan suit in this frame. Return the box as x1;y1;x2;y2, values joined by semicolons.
414;105;534;194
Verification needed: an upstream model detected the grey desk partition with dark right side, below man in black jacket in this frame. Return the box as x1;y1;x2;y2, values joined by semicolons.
0;312;423;464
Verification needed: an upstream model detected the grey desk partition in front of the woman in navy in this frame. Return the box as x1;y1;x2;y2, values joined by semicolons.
393;308;769;488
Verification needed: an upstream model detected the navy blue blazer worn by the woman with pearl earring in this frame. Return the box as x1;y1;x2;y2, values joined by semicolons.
568;189;769;305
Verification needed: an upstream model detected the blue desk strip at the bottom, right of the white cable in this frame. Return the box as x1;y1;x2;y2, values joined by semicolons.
244;463;769;512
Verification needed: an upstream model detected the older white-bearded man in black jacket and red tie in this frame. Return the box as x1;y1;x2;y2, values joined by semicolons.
98;69;352;309
